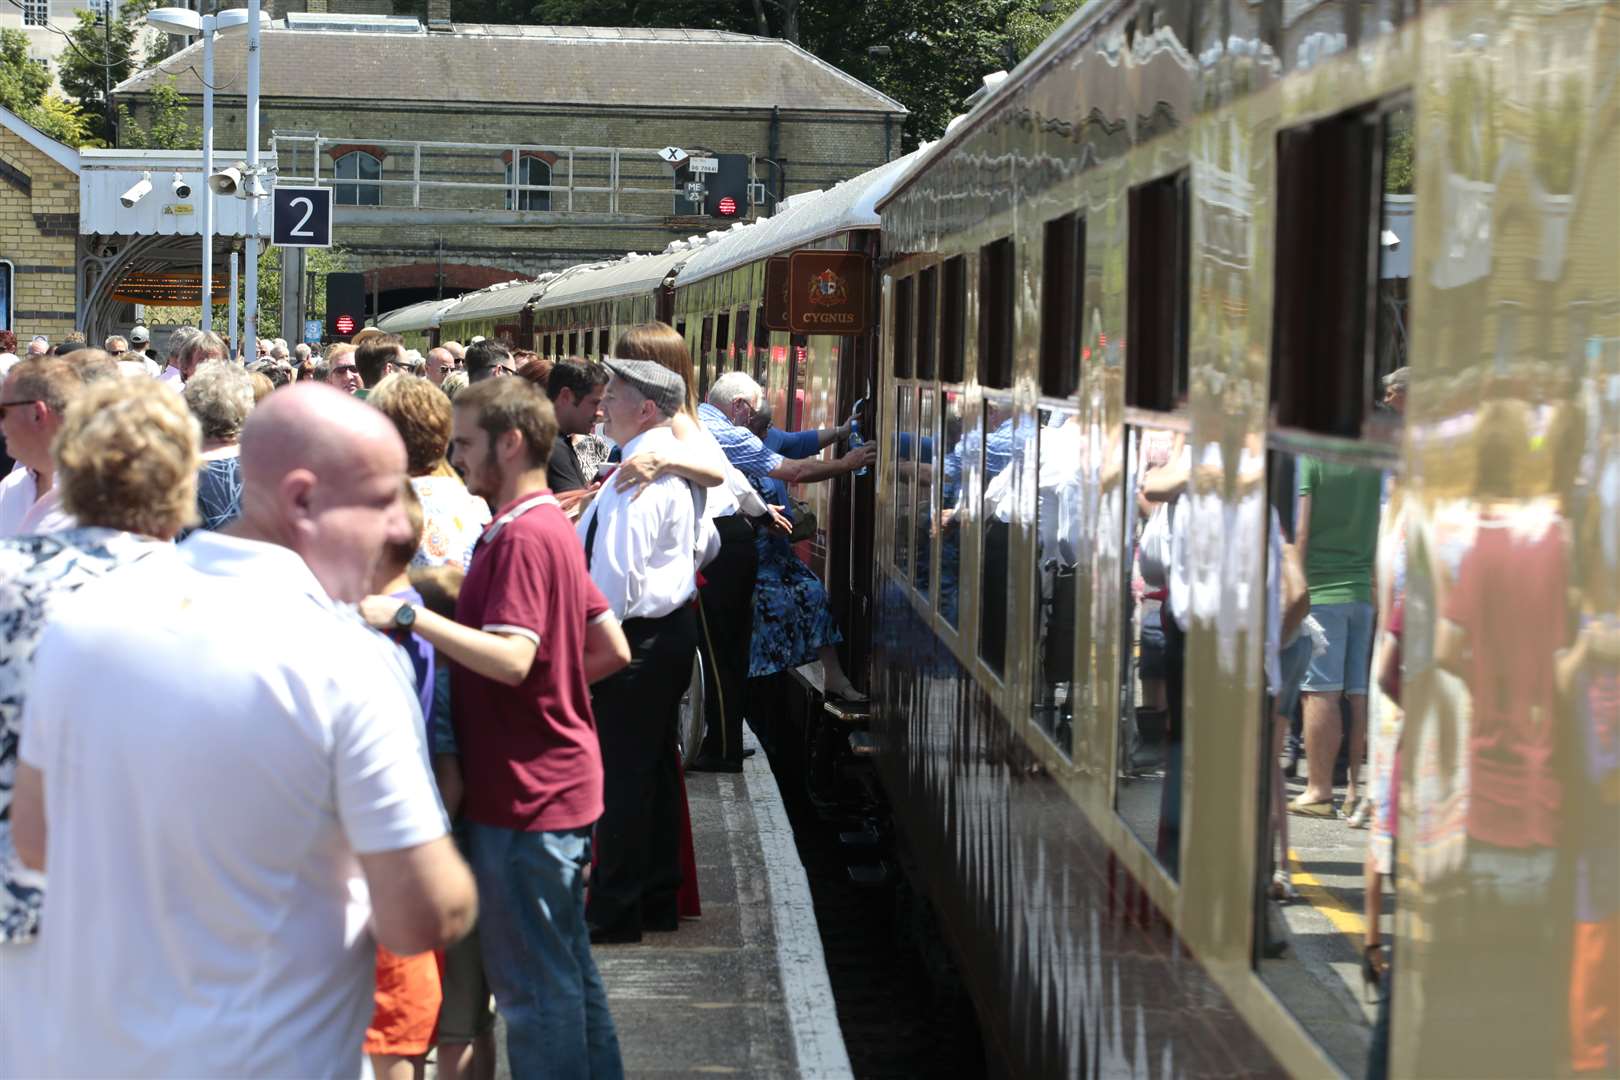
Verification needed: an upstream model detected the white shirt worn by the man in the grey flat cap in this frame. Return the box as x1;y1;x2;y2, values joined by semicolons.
577;424;700;622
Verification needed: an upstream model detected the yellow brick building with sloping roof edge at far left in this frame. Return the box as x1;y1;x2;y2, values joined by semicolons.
0;108;79;348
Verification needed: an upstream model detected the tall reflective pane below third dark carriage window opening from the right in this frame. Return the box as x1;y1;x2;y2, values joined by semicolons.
1030;401;1085;756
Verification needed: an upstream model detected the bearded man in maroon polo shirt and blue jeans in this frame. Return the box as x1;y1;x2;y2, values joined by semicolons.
363;379;630;1080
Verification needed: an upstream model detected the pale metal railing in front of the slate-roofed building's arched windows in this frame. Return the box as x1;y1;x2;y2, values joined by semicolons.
271;131;706;217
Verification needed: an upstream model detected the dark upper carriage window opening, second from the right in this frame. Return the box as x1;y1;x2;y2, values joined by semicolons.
1124;172;1191;413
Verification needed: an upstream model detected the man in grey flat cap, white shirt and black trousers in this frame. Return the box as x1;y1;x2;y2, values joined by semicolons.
578;358;703;944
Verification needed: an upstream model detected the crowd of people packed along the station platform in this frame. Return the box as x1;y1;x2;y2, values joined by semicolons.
0;324;875;1077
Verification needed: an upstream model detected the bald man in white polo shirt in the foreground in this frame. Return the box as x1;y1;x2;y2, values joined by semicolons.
13;384;476;1077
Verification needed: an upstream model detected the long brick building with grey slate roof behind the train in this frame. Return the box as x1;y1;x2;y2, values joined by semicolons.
115;13;906;311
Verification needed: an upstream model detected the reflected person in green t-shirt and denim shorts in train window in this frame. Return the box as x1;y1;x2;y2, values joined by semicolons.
1288;457;1382;827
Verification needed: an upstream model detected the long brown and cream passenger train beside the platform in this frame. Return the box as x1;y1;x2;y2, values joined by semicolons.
379;0;1620;1077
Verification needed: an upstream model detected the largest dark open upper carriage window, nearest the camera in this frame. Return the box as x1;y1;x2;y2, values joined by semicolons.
1272;105;1413;439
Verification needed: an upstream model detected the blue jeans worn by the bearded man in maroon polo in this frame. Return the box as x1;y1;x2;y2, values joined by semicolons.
468;823;624;1080
